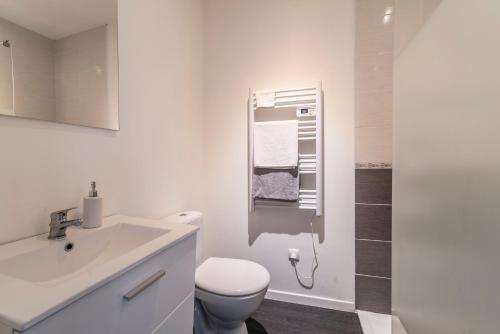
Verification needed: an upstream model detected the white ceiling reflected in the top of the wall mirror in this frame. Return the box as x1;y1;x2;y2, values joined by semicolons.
0;0;117;40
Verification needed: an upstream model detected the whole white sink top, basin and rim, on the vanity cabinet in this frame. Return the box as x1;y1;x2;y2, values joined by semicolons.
0;215;198;333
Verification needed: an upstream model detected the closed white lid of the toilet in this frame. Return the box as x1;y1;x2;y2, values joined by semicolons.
196;257;271;296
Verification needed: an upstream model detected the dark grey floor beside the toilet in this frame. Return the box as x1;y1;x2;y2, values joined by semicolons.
252;299;363;334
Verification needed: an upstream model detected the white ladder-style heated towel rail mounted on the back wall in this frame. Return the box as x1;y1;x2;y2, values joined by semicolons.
248;82;323;216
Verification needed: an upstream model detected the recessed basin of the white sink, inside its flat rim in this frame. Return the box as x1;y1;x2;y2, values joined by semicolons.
0;224;170;285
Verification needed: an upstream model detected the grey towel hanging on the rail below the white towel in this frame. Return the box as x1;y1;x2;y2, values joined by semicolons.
252;168;299;201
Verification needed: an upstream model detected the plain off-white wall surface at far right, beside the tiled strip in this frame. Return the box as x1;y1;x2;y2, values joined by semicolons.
393;0;500;334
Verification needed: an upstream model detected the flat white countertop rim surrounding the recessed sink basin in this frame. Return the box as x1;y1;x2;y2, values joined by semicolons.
0;215;198;331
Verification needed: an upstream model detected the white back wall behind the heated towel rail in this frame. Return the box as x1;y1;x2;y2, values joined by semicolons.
204;0;354;309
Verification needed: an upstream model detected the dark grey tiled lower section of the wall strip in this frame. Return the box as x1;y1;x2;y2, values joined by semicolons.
356;169;392;314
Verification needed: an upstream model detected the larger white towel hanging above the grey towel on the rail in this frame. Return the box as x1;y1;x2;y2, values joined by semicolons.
253;120;299;168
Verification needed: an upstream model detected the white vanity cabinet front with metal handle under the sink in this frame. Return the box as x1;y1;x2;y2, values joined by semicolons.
16;234;196;334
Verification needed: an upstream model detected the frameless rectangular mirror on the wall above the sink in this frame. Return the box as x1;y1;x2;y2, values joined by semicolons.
0;0;119;130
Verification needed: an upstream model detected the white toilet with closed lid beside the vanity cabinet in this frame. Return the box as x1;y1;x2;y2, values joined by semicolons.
165;211;271;334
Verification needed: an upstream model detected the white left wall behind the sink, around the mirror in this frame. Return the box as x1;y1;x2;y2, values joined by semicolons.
0;0;203;243
